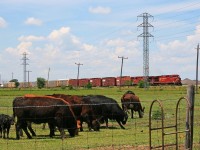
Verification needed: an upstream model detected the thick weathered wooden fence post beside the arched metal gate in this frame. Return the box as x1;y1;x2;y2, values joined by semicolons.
185;85;195;150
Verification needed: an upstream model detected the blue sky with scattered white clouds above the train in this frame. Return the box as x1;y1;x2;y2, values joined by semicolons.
0;0;200;82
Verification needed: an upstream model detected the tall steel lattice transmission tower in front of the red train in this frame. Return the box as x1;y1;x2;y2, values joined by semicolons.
138;13;153;88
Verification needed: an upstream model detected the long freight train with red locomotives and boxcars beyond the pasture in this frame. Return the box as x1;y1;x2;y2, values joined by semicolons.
4;74;182;88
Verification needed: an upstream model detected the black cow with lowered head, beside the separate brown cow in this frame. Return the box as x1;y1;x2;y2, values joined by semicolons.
87;95;128;129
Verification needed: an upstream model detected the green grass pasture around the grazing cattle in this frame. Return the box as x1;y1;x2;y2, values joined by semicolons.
0;86;200;150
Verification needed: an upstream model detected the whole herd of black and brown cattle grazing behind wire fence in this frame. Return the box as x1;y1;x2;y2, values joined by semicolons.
0;91;144;139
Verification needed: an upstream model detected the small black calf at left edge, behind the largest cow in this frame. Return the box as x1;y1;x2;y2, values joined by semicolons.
0;114;14;139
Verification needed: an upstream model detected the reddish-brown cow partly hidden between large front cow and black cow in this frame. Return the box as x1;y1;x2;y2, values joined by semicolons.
49;94;100;131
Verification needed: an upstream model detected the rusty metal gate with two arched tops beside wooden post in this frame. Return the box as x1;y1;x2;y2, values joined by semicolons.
149;97;191;150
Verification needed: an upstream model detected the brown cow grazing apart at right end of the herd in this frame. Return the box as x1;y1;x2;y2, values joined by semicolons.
121;91;145;118
